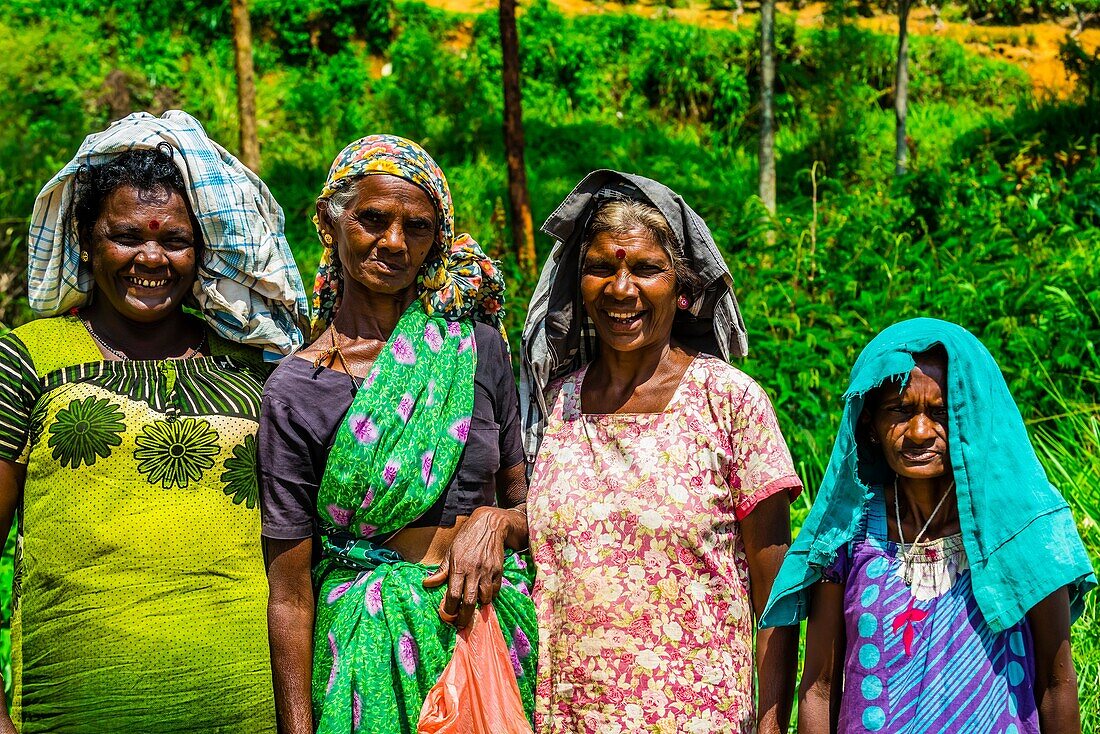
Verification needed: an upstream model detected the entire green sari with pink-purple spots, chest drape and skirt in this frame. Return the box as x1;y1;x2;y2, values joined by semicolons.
312;299;537;734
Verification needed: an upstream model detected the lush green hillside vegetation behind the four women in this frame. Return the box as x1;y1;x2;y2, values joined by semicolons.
0;0;1100;731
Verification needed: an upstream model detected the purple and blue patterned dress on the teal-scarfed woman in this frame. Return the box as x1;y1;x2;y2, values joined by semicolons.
825;490;1040;734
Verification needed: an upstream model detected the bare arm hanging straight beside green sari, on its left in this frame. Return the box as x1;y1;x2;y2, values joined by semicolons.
264;538;314;734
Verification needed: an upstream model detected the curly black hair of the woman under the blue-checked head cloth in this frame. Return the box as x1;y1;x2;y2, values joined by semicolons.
73;143;191;247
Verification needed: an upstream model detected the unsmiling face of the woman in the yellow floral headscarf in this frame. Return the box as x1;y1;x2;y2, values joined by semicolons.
322;174;438;295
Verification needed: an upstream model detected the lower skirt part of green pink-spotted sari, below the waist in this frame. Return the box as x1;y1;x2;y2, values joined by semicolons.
314;543;537;734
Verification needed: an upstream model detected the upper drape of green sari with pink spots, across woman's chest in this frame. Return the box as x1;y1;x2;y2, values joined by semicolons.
317;302;477;538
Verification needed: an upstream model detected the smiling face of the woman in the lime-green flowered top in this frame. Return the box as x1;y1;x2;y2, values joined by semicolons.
81;186;198;324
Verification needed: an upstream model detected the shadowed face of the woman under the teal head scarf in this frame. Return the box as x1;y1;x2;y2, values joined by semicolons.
871;355;950;480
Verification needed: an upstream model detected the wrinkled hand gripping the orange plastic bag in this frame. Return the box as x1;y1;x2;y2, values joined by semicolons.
424;506;527;629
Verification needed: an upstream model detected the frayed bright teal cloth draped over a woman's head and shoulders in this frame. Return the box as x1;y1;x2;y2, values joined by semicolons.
761;318;1097;632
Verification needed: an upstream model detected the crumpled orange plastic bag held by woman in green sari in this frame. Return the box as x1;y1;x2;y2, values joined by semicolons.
417;604;531;734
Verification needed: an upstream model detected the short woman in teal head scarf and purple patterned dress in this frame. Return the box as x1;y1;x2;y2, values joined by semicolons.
761;319;1096;734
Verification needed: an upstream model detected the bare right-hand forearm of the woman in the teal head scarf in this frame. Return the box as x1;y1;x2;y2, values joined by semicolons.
1027;587;1081;734
